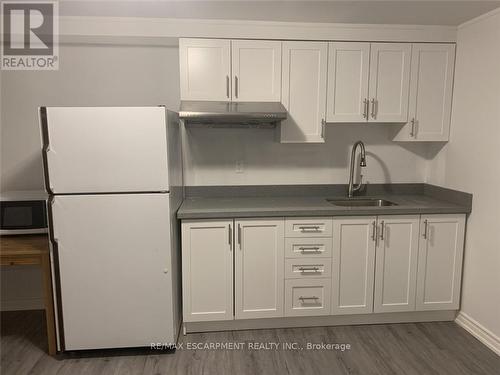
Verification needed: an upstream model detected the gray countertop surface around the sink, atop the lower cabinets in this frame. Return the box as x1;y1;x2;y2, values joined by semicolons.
177;194;471;219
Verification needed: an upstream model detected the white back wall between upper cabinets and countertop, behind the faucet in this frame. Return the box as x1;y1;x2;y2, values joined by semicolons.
184;124;427;185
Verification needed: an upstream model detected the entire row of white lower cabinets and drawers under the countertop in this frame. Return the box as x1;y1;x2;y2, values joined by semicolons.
182;214;465;323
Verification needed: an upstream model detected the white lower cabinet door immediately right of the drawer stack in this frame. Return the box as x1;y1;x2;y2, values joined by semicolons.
332;216;377;315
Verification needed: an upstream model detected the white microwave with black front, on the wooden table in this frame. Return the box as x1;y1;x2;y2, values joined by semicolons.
0;190;47;236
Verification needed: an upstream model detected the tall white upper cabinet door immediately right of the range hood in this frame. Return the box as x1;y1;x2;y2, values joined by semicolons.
281;42;328;143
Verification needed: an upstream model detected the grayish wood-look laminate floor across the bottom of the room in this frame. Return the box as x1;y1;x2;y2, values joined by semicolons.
0;311;500;375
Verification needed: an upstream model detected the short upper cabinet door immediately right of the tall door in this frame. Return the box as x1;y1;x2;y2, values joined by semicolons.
326;42;370;122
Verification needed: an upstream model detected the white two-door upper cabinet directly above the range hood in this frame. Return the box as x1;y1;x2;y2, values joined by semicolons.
179;38;281;102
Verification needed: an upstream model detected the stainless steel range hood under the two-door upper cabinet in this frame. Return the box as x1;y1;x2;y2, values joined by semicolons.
179;101;287;128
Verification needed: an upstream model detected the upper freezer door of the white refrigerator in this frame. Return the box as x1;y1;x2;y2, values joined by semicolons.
40;107;169;194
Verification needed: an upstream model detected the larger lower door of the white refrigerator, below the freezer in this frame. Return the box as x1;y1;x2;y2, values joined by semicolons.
51;194;175;350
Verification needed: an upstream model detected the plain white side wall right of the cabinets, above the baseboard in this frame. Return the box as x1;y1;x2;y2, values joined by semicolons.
430;11;500;350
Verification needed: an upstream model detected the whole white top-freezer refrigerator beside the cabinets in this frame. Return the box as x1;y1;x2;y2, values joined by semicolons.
40;106;183;351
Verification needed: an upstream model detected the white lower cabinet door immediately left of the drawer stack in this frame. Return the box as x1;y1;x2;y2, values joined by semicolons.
235;218;284;319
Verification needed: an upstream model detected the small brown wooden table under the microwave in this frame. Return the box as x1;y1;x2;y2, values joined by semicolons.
0;234;56;355
